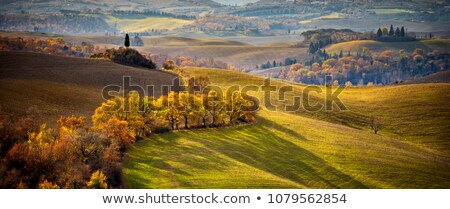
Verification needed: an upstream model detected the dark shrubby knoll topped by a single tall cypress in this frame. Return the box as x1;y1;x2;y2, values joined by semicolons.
91;47;156;69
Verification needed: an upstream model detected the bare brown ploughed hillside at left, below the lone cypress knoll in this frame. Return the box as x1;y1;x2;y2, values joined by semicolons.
0;52;176;124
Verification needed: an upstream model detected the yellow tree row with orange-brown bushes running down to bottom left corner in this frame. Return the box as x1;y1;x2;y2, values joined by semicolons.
0;77;258;189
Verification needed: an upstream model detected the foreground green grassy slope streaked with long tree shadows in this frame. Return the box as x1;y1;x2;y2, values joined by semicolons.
124;110;450;188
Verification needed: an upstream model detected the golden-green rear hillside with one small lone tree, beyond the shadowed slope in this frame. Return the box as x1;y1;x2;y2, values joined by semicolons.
182;68;450;151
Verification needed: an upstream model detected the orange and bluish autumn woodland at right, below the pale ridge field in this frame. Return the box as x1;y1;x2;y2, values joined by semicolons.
274;48;450;85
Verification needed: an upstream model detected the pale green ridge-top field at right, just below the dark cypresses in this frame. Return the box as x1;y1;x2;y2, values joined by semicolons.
326;39;450;54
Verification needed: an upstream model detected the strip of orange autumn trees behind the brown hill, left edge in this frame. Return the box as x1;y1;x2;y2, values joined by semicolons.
0;36;100;57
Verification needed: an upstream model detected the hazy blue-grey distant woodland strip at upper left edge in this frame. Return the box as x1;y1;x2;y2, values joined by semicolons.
0;13;112;34
